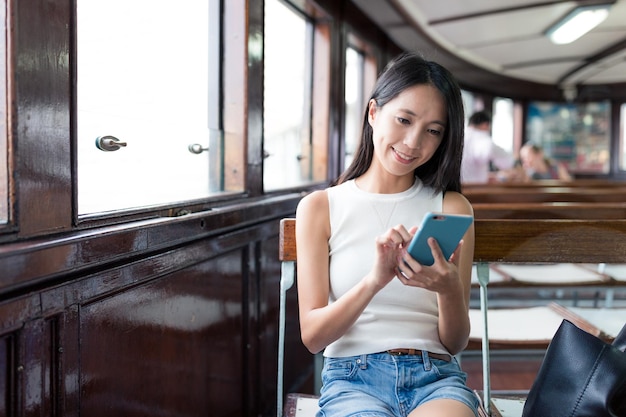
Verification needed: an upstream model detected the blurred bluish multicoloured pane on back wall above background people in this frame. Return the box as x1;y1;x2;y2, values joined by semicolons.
526;101;610;174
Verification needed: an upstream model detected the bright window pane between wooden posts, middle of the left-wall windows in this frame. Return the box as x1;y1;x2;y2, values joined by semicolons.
263;0;313;190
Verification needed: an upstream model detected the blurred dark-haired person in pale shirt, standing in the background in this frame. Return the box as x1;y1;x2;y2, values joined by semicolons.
461;111;515;184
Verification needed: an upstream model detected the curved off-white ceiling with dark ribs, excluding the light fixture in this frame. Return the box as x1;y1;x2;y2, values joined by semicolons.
353;0;626;90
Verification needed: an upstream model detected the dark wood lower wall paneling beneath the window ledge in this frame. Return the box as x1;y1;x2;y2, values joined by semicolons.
0;211;313;416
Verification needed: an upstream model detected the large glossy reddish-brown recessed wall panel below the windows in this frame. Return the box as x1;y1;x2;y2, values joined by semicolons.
80;251;248;417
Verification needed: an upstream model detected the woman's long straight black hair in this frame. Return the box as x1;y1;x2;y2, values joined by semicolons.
336;53;465;192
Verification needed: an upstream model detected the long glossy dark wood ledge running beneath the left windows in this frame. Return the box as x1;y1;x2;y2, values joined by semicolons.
0;194;300;296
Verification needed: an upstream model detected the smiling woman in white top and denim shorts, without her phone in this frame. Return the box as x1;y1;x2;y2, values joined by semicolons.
296;54;477;417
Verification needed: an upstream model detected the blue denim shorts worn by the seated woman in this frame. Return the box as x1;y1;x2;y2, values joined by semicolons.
317;352;478;417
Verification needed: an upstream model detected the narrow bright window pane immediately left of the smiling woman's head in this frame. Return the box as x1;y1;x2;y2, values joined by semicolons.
344;47;365;171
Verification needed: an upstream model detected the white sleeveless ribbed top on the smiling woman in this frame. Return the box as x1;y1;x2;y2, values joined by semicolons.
324;179;448;357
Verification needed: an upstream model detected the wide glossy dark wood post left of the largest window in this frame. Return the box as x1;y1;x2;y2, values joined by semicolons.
12;0;72;236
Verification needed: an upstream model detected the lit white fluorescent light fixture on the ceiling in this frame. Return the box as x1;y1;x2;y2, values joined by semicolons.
546;4;611;45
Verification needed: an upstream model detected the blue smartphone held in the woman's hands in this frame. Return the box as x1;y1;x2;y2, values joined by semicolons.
408;212;474;266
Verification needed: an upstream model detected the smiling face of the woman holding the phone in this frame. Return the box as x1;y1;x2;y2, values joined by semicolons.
368;84;448;176
